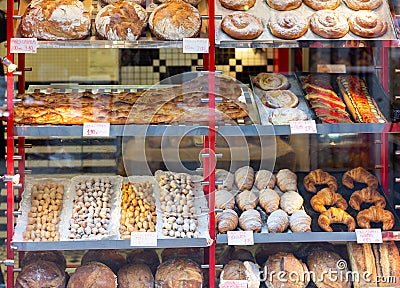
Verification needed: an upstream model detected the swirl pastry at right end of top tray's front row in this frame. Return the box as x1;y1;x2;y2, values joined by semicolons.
348;10;387;38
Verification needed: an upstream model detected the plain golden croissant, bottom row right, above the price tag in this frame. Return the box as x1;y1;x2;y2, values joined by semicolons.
357;206;394;230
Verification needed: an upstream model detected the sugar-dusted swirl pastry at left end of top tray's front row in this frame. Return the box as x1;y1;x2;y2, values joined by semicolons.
221;12;264;40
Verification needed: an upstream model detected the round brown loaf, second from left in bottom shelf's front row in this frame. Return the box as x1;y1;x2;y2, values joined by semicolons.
67;262;117;288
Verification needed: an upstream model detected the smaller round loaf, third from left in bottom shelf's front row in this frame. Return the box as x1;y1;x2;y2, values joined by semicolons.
117;264;154;288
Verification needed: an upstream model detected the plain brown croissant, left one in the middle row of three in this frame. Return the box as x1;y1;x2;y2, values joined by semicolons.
310;188;348;213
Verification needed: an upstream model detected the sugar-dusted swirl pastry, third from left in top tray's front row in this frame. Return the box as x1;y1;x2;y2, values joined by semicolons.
310;9;349;39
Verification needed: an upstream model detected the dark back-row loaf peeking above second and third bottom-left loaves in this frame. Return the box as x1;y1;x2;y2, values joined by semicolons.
81;249;126;274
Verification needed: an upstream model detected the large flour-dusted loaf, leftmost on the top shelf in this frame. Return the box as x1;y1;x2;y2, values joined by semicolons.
20;0;90;40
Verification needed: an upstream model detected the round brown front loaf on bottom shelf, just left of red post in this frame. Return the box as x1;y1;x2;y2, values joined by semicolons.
155;258;203;288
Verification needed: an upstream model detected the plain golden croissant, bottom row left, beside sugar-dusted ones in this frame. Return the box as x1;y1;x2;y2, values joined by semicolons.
318;207;356;232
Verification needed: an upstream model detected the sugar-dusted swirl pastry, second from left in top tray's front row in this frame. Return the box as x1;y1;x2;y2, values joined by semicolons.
268;11;308;39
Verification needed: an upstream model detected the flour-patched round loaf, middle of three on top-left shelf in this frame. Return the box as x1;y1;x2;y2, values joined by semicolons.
95;1;147;41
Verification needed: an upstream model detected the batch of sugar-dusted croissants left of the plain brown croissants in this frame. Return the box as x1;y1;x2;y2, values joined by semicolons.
215;166;311;233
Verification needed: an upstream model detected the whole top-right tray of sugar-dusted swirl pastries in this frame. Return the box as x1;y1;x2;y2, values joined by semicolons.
215;0;396;45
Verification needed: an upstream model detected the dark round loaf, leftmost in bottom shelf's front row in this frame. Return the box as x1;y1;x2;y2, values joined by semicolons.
14;260;67;288
